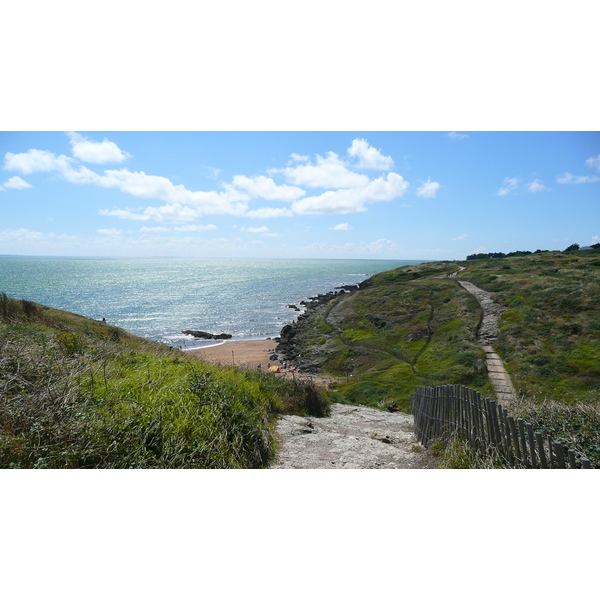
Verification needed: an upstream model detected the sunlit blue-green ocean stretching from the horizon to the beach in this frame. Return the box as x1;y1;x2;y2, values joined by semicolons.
0;256;423;349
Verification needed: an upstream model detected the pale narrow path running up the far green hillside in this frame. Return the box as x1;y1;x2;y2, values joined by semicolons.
458;281;516;404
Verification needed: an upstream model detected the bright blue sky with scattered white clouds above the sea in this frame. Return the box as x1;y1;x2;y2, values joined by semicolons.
0;131;600;260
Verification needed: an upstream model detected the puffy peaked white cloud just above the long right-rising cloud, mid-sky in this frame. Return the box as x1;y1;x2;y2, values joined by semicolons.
273;152;369;188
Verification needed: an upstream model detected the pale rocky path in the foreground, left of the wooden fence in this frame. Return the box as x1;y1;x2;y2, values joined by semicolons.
271;404;435;469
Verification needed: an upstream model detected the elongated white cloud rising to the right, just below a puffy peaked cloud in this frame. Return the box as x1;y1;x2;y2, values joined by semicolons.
292;173;409;215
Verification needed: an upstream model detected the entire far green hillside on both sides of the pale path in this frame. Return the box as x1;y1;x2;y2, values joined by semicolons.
280;250;600;462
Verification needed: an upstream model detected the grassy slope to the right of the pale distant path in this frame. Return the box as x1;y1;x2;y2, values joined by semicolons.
454;250;600;404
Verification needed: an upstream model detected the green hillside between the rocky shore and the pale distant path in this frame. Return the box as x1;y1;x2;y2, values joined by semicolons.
276;263;491;412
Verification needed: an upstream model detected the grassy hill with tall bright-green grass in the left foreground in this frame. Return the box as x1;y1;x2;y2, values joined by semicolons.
0;294;329;468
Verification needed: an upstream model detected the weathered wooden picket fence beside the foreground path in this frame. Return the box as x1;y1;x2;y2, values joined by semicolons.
411;385;591;469
